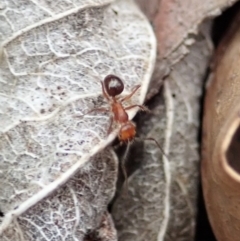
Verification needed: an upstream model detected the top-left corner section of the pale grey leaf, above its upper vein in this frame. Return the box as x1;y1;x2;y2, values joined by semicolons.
0;0;114;40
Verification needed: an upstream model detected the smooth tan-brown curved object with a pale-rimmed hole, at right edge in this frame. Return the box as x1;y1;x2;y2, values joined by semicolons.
202;8;240;241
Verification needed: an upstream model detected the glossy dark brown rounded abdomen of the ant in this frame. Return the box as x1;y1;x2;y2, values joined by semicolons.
103;75;124;97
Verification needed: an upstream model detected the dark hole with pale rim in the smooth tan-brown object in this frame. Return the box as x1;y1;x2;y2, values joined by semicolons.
227;123;240;173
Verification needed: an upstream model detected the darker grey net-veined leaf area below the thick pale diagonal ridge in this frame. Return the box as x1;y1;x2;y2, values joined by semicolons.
1;150;118;241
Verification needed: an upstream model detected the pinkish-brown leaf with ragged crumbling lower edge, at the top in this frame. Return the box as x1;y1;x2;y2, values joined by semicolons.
137;0;237;99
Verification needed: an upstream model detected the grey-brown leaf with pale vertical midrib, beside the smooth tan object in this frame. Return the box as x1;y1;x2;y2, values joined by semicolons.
113;21;212;241
